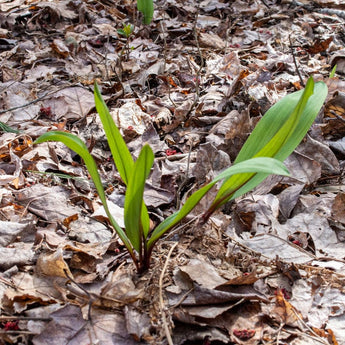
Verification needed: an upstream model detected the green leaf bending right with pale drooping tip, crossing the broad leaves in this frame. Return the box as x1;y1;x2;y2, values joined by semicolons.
148;157;289;248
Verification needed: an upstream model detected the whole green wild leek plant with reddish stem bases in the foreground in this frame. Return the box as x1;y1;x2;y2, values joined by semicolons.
35;78;327;273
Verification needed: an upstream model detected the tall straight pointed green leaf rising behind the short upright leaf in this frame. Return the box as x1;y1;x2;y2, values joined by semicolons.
94;82;134;185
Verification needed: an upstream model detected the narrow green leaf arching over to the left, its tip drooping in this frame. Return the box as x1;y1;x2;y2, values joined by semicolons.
34;131;134;257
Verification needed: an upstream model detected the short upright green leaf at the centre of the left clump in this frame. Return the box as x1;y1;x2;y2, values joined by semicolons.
124;145;154;253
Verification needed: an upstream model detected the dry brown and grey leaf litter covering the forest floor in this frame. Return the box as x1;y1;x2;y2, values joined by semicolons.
0;0;345;345
